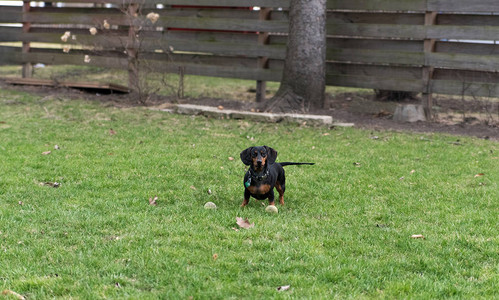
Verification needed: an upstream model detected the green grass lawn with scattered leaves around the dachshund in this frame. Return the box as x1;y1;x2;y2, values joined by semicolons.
0;90;499;299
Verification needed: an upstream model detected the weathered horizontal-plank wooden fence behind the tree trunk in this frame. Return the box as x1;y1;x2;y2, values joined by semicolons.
0;0;499;107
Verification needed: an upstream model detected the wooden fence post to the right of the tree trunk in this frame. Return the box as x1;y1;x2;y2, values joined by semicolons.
422;11;437;121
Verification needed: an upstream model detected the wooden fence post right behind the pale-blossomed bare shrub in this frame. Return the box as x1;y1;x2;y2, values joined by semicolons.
126;3;140;92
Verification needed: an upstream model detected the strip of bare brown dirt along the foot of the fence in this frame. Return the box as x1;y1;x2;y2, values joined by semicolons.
0;79;499;140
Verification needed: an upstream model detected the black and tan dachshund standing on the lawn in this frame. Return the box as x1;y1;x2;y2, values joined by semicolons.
240;146;314;207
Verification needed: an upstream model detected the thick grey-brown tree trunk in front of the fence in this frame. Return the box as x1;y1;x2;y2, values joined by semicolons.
263;0;326;112
